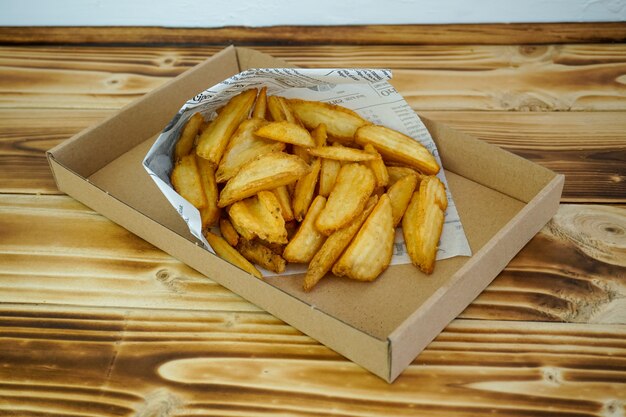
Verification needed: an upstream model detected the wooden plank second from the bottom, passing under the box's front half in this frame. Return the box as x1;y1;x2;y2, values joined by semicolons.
0;195;626;323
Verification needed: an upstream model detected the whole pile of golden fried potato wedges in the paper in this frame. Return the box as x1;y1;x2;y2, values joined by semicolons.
171;88;448;291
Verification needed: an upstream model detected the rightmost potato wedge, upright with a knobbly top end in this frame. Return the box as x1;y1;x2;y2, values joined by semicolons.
402;176;448;274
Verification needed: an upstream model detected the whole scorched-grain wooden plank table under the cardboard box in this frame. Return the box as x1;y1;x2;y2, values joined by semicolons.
0;24;626;417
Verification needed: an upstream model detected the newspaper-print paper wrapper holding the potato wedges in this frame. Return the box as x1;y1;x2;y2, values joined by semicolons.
143;68;471;275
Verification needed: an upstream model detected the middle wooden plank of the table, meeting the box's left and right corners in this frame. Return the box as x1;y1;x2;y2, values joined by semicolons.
0;109;626;203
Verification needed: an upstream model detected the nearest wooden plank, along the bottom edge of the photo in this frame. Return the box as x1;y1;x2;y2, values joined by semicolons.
0;303;626;417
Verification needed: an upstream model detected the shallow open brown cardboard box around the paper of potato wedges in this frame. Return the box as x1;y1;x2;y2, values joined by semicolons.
48;46;563;382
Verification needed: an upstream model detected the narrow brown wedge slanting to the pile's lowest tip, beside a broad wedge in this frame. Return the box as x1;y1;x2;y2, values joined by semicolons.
303;196;378;291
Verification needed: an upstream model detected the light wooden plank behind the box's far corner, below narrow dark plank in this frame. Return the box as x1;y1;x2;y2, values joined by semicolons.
0;44;626;111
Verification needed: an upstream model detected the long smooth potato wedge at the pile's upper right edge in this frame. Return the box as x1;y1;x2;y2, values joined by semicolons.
354;125;439;175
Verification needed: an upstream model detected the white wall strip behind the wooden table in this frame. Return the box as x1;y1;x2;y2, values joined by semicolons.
0;0;626;27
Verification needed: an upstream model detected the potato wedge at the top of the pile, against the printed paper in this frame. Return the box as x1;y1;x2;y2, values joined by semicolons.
287;99;370;144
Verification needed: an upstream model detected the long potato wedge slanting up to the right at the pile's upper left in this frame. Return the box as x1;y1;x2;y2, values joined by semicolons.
196;88;257;166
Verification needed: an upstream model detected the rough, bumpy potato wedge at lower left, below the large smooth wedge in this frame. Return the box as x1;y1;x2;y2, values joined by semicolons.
228;191;287;243
